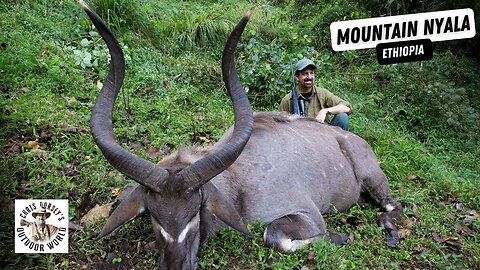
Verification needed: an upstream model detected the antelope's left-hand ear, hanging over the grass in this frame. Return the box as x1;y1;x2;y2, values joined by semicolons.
95;184;147;240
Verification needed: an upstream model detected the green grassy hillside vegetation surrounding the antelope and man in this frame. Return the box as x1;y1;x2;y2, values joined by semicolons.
0;0;480;269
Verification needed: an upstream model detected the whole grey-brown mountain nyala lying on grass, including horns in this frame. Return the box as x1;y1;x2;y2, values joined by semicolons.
79;0;401;269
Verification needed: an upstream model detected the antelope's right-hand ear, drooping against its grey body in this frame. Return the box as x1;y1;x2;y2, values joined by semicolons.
202;183;254;237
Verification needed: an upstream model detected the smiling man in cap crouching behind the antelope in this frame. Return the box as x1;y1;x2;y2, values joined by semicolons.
280;58;352;131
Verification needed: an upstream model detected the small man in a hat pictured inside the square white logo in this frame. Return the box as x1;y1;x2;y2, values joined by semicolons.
20;208;58;242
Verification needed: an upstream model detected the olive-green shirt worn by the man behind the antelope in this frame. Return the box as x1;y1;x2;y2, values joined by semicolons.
279;86;352;117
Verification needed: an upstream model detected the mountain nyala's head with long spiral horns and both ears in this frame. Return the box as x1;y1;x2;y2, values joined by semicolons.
78;0;253;269
